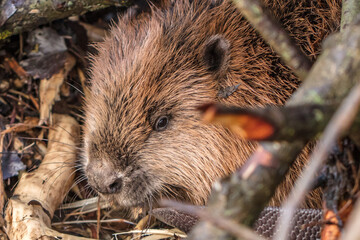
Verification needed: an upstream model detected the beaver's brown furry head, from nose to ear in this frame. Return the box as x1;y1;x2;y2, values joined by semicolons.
84;2;243;206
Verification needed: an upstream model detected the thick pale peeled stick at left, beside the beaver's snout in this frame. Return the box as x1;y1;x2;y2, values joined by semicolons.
5;114;92;240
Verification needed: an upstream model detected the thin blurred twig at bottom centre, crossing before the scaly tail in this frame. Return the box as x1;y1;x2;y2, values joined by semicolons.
161;200;265;240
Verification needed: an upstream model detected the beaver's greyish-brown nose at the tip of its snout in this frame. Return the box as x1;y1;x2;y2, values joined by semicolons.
85;160;123;194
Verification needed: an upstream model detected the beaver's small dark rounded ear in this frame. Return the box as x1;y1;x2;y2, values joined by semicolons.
203;35;230;72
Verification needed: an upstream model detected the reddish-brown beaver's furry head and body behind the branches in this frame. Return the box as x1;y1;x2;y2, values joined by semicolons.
83;0;341;210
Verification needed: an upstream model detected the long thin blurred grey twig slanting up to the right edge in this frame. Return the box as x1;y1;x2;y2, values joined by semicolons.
275;84;360;240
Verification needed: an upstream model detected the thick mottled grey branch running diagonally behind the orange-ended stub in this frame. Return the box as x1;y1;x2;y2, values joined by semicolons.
190;20;360;239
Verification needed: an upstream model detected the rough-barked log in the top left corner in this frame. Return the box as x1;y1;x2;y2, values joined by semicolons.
0;0;131;40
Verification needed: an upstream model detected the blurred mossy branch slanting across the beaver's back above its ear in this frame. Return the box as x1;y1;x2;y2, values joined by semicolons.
233;0;312;80
